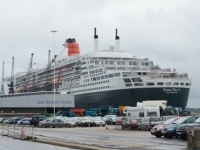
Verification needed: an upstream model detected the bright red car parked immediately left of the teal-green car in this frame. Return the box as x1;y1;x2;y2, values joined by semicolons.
151;117;179;138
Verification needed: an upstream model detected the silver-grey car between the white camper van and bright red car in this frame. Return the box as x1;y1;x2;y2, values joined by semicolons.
138;117;162;131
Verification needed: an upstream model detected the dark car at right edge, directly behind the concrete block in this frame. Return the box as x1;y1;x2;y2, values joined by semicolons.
176;117;200;140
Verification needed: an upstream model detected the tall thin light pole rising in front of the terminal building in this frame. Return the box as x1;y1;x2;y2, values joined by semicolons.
51;31;57;117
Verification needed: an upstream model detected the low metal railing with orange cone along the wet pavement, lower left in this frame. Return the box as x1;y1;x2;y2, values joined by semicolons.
0;123;35;140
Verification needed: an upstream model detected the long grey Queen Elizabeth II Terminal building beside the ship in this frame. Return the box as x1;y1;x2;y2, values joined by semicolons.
0;91;75;116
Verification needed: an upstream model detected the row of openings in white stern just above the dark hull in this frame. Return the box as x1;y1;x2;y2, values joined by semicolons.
126;82;190;87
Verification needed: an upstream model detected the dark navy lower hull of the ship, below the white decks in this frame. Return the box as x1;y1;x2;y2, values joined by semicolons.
75;87;190;109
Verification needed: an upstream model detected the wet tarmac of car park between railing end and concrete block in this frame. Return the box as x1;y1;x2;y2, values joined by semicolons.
28;125;187;150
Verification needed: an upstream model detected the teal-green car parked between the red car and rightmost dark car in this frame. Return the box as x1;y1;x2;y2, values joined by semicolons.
161;116;199;138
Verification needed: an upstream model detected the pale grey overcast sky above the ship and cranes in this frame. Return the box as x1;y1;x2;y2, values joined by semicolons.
0;0;200;108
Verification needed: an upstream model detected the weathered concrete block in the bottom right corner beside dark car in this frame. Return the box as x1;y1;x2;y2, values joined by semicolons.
187;127;200;150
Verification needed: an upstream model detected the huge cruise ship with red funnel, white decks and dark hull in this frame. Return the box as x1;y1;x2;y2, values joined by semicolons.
10;28;191;109
